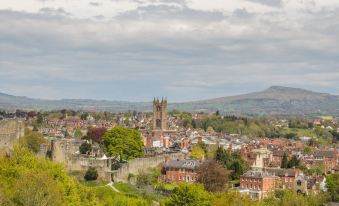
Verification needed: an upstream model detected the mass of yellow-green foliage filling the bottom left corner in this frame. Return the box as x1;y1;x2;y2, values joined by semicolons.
0;145;99;206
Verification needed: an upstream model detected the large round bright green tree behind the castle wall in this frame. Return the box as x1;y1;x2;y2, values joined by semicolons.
102;126;144;160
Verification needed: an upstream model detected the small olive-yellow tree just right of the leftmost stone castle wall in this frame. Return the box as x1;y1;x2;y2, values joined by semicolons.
20;129;45;153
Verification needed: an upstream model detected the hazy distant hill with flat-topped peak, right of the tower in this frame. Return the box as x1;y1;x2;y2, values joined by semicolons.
171;86;339;116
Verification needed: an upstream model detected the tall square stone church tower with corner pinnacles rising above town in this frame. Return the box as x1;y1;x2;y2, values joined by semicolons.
153;98;167;131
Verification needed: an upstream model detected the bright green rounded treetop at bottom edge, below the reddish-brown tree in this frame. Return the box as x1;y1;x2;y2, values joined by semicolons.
165;183;212;206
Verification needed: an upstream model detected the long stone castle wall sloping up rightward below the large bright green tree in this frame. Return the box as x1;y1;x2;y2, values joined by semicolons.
113;153;184;182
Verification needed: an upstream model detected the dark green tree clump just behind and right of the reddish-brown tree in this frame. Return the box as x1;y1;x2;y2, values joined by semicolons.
215;147;249;180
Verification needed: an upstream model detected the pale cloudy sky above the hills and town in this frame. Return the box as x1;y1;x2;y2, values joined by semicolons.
0;0;339;102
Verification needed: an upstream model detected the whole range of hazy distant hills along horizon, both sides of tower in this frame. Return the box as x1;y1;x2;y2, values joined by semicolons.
0;86;339;116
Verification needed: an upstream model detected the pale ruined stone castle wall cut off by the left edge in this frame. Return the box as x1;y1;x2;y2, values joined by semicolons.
0;119;25;150
